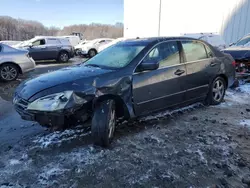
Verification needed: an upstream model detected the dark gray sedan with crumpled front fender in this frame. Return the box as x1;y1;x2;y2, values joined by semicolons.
13;38;235;146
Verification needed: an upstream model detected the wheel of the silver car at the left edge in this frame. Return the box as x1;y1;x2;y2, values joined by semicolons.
0;63;19;82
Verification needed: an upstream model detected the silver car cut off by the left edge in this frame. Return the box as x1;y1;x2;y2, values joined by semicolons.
0;43;36;81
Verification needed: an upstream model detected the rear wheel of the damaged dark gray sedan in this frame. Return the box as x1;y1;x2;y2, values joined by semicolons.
206;77;227;105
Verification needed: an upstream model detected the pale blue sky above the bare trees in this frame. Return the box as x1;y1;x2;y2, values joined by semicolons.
0;0;123;27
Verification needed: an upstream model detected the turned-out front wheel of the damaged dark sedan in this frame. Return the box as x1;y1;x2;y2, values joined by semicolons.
91;100;116;147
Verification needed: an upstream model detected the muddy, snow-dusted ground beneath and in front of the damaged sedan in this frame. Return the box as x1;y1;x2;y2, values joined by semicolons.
0;61;250;188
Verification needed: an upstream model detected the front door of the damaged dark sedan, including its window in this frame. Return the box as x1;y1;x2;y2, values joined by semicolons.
133;41;186;115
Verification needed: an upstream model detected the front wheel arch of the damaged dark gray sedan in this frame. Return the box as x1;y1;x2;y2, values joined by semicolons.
92;94;130;119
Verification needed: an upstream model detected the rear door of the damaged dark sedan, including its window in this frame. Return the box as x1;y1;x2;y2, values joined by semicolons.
181;40;219;101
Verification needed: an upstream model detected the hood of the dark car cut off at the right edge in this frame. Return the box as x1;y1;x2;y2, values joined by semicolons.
222;46;250;60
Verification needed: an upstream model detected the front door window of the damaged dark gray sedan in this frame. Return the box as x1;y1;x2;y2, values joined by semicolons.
143;41;180;67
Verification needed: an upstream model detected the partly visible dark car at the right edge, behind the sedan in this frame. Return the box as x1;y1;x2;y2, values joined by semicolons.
222;34;250;73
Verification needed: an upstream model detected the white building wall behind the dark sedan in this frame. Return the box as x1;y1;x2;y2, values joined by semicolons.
124;0;250;44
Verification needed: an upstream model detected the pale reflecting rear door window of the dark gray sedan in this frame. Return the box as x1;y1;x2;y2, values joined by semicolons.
181;41;208;62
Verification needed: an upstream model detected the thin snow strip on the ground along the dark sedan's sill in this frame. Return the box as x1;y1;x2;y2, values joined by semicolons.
140;103;201;121
